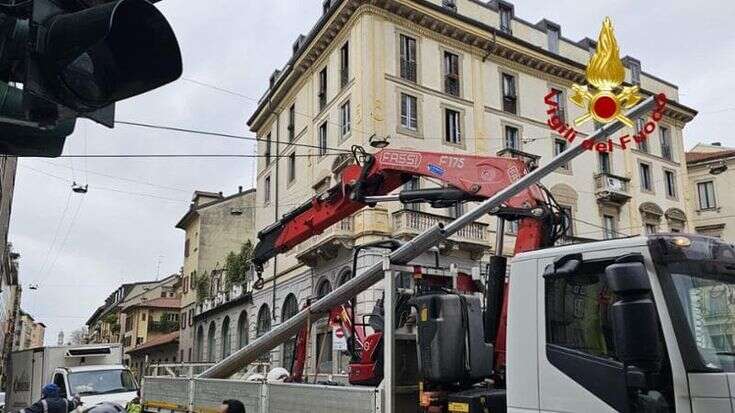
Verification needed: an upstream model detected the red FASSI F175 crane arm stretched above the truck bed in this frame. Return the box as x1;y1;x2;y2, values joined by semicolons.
253;149;544;269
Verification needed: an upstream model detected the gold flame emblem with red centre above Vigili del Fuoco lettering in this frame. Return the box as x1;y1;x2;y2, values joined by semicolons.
569;17;641;128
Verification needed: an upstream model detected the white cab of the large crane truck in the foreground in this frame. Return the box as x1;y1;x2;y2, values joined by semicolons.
507;234;735;413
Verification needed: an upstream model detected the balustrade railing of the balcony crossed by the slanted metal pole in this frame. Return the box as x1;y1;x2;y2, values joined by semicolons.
393;209;489;249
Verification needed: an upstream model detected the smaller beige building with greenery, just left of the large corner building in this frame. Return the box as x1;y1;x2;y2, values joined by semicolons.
176;187;256;362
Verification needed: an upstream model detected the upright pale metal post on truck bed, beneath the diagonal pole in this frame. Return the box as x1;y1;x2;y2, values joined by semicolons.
383;255;396;413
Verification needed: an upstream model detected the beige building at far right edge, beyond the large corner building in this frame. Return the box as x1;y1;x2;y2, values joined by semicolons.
686;143;735;242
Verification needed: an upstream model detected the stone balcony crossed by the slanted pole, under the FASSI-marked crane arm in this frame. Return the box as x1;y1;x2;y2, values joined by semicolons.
393;209;490;258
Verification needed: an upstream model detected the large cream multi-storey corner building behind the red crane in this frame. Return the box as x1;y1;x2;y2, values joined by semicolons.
248;0;696;373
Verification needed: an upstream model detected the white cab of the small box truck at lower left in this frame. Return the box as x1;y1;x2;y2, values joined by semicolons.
52;365;138;410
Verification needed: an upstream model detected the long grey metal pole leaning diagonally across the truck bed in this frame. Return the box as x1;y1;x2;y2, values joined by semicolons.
199;96;655;378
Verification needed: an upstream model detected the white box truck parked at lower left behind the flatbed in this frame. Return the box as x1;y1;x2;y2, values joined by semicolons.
6;344;139;411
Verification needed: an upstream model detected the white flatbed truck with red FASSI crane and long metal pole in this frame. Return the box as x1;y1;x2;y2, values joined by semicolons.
143;97;720;413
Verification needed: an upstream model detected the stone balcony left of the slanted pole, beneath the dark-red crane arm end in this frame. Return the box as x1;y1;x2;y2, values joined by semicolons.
295;217;355;267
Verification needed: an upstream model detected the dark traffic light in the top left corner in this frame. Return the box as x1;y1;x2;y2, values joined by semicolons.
0;0;182;156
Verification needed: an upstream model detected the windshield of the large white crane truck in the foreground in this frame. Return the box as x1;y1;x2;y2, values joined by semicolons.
655;233;735;372
